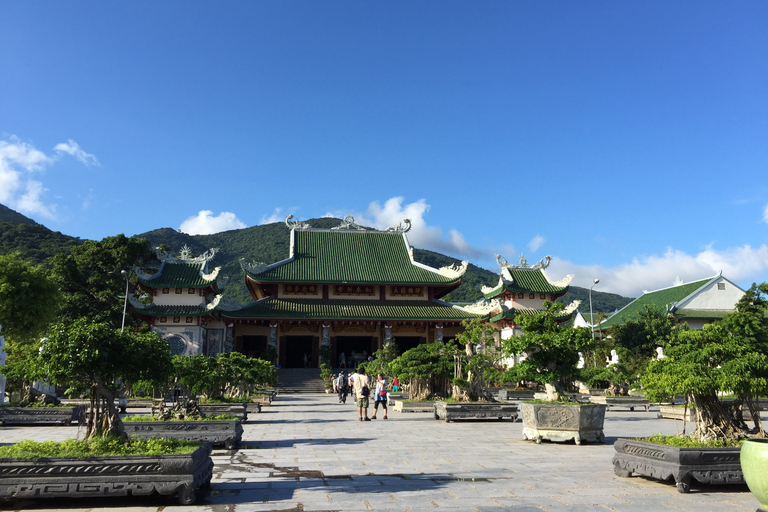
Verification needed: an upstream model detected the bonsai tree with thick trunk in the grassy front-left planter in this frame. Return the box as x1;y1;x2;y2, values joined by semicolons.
34;318;171;438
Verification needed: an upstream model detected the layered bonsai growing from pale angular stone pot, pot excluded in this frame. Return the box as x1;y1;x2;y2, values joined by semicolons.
502;302;592;401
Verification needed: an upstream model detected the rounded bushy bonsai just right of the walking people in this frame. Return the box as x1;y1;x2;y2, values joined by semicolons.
390;341;456;400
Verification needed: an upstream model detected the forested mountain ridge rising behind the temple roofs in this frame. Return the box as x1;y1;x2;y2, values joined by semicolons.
138;218;631;313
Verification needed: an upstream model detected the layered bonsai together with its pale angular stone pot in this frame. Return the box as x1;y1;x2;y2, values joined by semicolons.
503;302;605;444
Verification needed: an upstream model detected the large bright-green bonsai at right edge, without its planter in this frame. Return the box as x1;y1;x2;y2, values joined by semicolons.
643;283;768;441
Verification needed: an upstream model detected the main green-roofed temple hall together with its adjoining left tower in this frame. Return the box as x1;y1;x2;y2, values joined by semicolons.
131;216;486;368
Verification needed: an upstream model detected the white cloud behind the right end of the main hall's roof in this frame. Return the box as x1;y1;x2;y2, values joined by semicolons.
326;197;487;258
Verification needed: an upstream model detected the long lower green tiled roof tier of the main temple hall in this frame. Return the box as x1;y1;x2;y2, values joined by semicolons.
221;297;480;321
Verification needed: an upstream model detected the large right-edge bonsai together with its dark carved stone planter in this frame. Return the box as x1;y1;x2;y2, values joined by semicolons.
613;283;768;492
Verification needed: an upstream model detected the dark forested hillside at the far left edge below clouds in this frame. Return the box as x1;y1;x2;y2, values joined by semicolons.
0;204;83;263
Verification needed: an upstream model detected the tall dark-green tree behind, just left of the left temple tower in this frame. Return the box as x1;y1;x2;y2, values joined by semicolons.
53;234;156;327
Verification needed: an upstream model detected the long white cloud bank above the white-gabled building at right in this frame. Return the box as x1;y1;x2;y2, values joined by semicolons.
547;244;768;297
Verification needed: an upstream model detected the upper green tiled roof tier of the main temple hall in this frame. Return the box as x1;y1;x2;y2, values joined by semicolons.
247;230;461;285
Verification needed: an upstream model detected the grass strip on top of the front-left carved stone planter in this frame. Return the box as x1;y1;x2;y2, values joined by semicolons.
0;437;200;460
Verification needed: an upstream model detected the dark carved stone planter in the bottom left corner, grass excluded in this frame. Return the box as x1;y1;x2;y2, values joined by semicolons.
0;444;213;505
